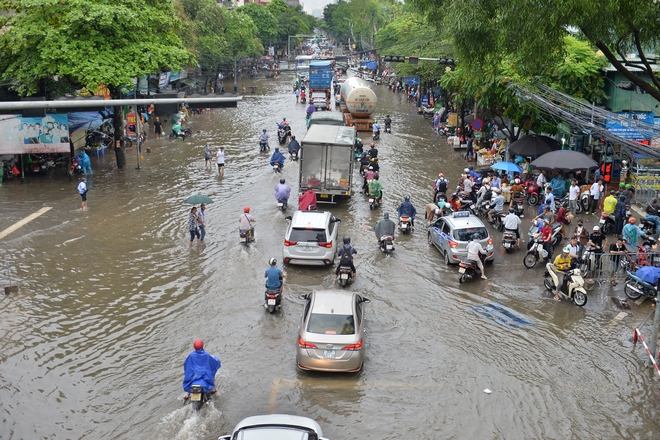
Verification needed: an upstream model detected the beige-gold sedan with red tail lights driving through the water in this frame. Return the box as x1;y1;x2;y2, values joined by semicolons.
296;290;371;372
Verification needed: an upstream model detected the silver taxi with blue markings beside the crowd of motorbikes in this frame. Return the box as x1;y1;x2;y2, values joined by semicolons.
428;211;495;265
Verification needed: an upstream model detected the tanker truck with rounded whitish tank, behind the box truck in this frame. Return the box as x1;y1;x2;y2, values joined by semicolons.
340;77;378;131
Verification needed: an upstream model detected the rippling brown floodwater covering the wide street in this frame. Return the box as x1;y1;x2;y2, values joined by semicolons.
0;75;660;439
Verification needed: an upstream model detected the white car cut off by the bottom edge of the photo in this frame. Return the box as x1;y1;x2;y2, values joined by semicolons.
218;414;327;440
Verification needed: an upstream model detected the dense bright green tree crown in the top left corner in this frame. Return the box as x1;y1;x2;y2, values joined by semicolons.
0;0;193;96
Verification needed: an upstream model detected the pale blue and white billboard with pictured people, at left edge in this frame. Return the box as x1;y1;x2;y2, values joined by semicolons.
0;113;70;155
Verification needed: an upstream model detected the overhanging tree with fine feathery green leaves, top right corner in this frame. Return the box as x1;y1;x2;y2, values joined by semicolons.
412;0;660;101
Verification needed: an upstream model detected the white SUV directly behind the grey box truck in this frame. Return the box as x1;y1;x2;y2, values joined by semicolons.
282;211;341;266
